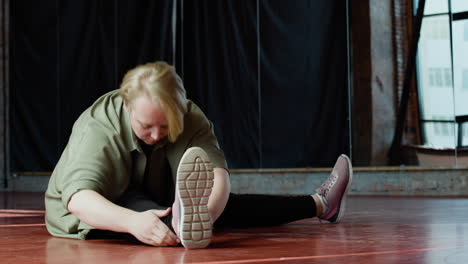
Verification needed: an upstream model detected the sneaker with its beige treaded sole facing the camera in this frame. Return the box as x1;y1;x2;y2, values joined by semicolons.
172;147;213;249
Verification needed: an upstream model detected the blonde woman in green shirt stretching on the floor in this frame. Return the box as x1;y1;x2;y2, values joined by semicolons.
45;62;352;248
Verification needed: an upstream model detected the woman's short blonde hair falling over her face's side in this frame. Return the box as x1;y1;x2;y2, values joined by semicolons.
119;61;187;142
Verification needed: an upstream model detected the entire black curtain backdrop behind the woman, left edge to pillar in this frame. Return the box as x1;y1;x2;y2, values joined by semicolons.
10;0;349;171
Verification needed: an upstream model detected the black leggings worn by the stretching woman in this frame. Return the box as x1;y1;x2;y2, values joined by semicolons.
87;191;316;239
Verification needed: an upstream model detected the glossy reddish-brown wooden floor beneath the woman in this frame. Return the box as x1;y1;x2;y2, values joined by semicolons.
0;193;468;264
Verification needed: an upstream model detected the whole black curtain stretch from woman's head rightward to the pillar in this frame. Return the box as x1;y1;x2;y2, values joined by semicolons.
183;0;349;168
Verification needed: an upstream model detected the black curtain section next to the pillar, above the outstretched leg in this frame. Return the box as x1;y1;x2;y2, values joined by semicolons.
260;0;348;167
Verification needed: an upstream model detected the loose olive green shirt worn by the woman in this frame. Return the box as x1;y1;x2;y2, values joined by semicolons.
45;90;227;239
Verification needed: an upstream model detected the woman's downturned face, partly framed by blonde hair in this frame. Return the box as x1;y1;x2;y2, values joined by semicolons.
127;95;169;145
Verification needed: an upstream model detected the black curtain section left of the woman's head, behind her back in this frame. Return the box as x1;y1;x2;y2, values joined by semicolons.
10;0;176;171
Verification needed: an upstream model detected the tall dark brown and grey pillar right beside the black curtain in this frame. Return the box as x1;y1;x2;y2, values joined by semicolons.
351;0;397;166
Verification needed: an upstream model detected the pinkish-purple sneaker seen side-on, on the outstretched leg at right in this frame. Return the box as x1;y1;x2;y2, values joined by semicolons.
315;154;353;224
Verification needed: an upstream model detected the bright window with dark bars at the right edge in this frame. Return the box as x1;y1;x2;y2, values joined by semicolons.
414;0;468;148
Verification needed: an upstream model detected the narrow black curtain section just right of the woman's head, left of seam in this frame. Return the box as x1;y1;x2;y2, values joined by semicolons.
182;0;261;168
